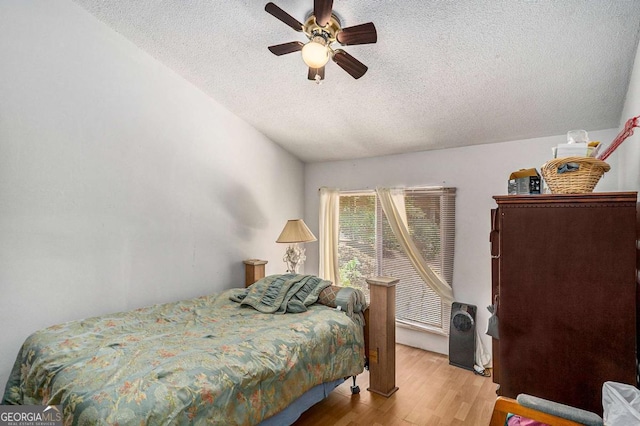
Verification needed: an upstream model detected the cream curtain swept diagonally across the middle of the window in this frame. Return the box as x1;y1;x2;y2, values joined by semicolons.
376;188;453;305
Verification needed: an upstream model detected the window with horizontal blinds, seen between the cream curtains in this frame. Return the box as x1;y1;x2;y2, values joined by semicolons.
338;188;455;333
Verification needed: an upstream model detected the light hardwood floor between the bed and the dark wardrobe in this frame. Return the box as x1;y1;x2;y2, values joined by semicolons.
294;345;496;426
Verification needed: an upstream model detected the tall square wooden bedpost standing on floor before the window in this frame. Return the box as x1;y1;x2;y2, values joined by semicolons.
366;277;400;397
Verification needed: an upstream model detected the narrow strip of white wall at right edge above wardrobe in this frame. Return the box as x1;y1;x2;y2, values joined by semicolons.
612;38;640;191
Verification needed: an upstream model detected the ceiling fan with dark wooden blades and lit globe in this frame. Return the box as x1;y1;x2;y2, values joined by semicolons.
264;0;378;84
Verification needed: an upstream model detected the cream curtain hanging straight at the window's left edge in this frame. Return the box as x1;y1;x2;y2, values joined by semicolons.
318;187;340;285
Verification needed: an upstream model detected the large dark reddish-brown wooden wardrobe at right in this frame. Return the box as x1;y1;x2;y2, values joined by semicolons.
490;192;638;414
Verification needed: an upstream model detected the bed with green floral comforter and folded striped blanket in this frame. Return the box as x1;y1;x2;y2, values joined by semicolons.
2;274;366;425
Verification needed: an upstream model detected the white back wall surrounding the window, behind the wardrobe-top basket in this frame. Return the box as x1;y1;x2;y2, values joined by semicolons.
305;126;617;353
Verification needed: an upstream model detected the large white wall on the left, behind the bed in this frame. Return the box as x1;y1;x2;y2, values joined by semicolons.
0;0;304;392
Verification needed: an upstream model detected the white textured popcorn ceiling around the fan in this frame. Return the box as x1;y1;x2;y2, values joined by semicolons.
74;0;640;162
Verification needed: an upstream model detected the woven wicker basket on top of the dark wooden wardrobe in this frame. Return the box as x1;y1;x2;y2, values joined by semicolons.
541;157;611;194
